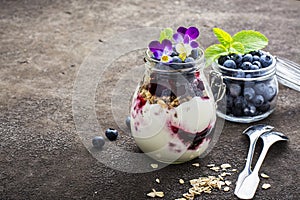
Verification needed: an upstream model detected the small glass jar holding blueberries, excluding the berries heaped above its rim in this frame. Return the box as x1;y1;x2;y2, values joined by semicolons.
212;52;278;123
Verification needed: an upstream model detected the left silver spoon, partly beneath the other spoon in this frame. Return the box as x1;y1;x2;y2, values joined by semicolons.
234;124;274;193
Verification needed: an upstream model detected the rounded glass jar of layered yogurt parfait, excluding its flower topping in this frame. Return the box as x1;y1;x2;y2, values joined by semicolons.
130;48;225;163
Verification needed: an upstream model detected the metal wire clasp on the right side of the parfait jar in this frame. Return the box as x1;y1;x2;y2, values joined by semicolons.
209;70;226;105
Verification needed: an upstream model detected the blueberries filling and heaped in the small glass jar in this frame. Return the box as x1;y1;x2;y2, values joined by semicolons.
218;51;278;117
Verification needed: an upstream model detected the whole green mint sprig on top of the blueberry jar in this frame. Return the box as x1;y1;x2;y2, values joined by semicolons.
204;28;269;65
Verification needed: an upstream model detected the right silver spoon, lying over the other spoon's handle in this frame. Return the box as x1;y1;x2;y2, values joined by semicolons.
235;132;288;199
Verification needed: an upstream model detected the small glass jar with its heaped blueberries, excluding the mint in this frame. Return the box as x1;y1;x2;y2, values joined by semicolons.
212;50;278;123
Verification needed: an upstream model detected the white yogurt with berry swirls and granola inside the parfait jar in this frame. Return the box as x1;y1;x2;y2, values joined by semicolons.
131;79;216;163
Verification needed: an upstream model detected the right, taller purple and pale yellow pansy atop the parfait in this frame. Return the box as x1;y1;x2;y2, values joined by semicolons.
173;27;199;60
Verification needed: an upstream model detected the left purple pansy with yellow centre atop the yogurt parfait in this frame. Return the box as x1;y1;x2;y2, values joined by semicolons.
149;39;173;62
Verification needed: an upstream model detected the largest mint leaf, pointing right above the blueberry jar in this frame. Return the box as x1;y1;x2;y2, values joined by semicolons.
232;30;269;53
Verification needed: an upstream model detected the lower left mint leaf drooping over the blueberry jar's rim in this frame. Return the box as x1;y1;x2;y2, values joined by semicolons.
204;44;229;66
